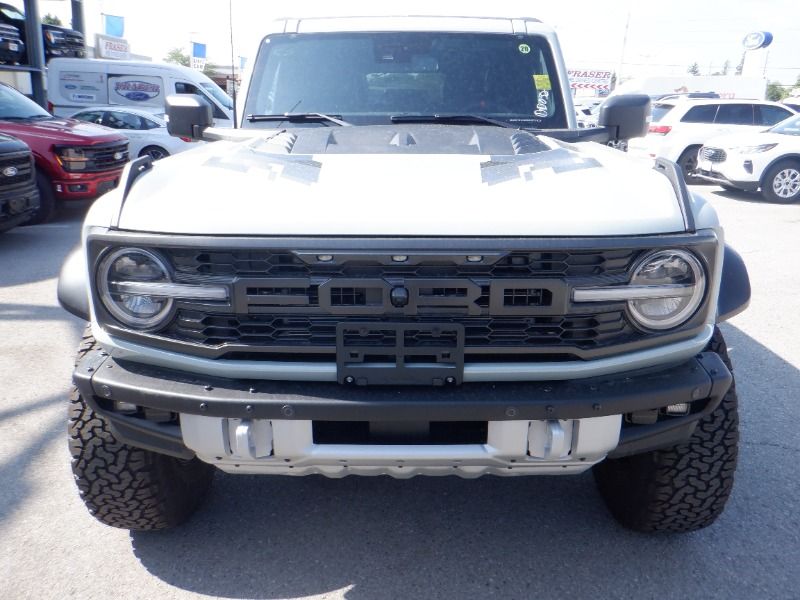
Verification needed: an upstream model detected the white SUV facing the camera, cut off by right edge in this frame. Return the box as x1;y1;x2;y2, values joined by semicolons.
697;115;800;203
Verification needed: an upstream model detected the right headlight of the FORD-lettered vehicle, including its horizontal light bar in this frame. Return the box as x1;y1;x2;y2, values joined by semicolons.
572;250;706;330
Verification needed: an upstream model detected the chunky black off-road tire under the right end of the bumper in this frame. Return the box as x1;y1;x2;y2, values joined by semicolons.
593;330;739;532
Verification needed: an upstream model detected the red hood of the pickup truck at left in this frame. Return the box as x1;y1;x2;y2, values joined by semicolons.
0;118;127;146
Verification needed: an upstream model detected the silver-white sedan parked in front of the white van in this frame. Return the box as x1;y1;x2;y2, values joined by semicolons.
72;106;197;160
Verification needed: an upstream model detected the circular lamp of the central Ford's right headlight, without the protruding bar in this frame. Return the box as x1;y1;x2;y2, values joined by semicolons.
628;250;706;329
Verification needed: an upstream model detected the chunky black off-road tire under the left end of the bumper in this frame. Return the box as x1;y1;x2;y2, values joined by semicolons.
68;329;214;531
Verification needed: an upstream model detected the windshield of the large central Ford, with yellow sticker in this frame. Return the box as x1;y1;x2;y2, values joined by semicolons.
243;32;567;129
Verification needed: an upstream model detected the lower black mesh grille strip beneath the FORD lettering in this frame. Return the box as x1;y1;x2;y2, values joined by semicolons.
169;310;638;354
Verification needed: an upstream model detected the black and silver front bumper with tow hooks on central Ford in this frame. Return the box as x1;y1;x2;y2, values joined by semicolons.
74;350;732;476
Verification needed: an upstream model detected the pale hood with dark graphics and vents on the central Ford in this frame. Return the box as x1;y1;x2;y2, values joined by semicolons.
119;125;684;236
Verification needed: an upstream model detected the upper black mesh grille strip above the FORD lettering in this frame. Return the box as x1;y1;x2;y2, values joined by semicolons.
169;249;640;278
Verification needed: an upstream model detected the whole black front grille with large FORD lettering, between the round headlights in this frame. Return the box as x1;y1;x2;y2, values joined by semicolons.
139;247;647;362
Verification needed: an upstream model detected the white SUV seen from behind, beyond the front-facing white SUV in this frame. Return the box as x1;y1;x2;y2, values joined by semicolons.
628;98;795;183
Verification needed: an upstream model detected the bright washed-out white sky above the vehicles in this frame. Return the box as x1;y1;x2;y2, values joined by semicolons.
32;0;800;85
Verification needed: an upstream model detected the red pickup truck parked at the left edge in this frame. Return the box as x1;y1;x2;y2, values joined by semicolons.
0;84;128;224
